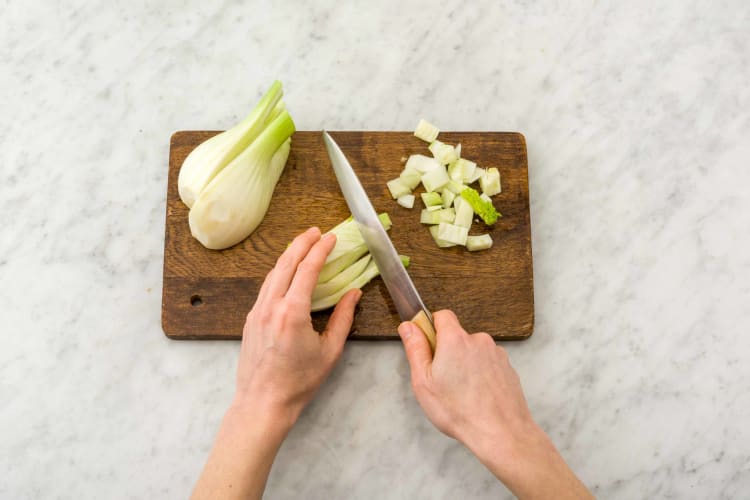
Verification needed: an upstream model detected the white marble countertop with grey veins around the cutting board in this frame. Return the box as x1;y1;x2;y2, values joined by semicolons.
0;0;750;499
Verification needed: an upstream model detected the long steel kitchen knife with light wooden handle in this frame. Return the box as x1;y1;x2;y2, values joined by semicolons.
323;131;435;352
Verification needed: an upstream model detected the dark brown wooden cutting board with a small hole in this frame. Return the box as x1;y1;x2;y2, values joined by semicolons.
162;131;534;339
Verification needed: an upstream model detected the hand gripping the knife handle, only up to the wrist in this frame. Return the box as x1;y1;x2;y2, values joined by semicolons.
398;310;535;458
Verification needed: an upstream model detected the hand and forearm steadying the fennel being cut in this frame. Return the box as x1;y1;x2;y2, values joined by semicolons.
193;228;362;499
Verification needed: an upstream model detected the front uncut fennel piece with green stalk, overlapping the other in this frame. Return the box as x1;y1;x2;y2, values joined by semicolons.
188;110;294;250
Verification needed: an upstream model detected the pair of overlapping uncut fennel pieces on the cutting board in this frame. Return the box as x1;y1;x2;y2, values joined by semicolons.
177;81;294;250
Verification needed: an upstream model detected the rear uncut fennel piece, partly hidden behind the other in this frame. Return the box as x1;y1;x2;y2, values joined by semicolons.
177;81;285;208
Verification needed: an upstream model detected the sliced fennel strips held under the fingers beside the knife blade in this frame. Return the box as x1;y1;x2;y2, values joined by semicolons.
311;213;409;311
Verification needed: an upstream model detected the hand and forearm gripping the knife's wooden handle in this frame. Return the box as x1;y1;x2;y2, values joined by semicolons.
398;310;593;499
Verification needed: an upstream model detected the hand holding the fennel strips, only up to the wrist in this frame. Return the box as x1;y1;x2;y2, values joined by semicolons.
235;228;362;427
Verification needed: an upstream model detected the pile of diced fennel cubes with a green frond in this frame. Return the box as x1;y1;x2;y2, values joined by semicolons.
386;120;502;252
